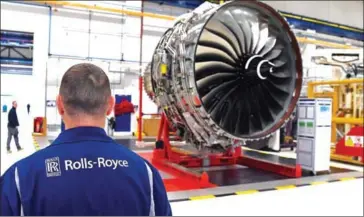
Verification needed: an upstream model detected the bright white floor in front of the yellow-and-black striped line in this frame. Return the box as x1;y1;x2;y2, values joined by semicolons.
171;179;363;216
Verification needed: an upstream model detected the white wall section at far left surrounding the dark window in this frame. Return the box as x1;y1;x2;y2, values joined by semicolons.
1;2;49;119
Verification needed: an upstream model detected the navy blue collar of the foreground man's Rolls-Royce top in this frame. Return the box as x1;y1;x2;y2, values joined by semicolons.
52;127;113;145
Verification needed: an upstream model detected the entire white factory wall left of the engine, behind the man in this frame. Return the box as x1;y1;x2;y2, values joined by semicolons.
1;2;164;134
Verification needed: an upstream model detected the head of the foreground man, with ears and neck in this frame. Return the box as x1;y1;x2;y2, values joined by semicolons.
57;63;114;128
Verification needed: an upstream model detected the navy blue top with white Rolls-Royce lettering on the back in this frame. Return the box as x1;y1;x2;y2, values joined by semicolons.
0;127;172;216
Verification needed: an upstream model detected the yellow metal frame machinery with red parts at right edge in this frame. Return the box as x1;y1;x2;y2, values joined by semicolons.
307;78;364;165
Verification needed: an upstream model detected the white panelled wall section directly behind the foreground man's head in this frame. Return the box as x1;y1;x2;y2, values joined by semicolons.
47;2;164;131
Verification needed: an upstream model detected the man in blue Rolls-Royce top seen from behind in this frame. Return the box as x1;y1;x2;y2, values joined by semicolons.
0;64;172;216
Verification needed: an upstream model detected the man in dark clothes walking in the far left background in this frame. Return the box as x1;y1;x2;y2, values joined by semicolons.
6;101;22;154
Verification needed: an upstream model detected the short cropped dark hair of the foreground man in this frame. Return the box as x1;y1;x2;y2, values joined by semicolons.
59;63;111;116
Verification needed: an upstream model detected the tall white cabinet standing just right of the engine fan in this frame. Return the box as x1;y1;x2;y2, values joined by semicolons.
296;99;332;175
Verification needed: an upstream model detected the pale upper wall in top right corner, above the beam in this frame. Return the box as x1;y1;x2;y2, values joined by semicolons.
262;0;363;29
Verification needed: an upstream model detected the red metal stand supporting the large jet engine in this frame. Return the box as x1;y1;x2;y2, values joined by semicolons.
152;113;301;188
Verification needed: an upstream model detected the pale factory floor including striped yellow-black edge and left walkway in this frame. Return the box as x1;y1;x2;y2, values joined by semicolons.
1;117;363;216
